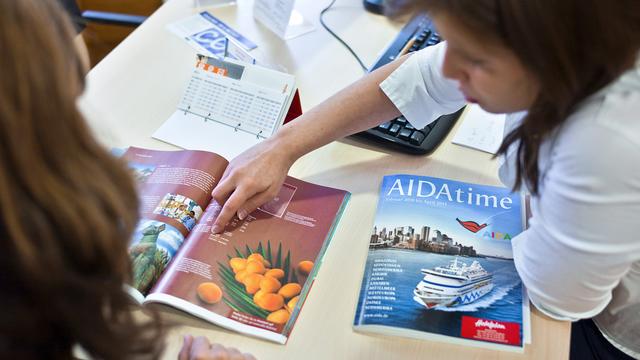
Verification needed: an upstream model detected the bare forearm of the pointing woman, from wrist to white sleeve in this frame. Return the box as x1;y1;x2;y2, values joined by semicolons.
270;57;406;159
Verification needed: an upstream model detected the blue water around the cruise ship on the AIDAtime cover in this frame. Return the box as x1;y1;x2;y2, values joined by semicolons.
356;248;522;337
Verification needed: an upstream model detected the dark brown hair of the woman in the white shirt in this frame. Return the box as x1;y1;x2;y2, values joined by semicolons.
389;0;640;194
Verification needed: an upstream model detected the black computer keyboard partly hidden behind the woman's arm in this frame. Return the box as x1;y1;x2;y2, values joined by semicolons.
354;14;464;155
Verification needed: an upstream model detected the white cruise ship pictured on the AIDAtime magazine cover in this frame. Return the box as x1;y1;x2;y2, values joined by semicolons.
413;258;493;309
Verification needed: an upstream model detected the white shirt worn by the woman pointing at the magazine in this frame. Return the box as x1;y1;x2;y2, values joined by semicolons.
380;43;640;358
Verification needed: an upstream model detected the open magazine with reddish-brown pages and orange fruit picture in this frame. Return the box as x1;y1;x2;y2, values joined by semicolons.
123;147;349;344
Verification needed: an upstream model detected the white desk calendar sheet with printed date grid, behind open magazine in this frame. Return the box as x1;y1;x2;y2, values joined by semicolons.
153;56;295;159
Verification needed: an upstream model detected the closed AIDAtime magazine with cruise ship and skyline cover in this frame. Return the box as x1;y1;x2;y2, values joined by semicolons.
354;175;529;351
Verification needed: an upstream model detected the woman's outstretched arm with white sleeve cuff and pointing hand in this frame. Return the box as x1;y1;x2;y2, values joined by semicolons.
212;43;464;232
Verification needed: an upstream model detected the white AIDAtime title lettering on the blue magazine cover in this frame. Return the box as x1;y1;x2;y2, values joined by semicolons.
387;179;513;210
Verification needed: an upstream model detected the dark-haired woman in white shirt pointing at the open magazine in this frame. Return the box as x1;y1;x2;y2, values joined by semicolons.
213;0;640;359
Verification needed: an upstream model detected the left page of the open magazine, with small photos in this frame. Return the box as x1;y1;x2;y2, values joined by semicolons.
123;147;228;301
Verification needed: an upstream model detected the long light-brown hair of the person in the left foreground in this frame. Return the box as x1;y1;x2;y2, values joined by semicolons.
0;0;162;359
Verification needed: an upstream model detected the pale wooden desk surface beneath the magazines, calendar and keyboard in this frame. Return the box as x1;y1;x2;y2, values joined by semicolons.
82;0;570;360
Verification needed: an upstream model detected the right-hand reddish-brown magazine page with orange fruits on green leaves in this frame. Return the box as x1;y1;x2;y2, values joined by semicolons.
146;177;349;344
